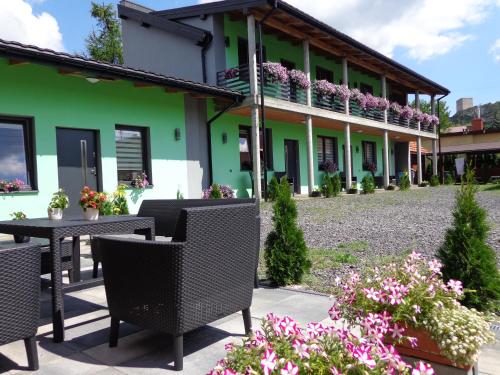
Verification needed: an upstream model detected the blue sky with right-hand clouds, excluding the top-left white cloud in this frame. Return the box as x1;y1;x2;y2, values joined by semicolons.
4;0;500;114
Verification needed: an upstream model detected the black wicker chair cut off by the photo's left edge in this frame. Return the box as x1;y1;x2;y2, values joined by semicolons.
0;245;40;370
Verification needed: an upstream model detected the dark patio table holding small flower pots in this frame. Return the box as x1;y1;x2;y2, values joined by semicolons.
0;215;155;342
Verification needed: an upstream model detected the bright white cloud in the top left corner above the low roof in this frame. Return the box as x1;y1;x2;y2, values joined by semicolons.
0;0;64;51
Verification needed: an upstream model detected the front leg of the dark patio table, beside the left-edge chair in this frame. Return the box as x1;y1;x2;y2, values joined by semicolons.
50;237;64;342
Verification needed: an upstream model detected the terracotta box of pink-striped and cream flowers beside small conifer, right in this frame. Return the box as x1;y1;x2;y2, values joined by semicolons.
334;252;495;369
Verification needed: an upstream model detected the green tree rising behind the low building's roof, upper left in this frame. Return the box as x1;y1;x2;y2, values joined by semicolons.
85;2;123;64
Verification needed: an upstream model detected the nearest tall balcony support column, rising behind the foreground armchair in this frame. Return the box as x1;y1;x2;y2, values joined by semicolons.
247;14;262;200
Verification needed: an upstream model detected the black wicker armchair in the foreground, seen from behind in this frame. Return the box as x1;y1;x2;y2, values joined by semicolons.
96;204;257;370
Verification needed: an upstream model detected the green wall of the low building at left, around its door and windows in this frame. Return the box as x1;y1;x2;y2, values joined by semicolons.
0;59;188;220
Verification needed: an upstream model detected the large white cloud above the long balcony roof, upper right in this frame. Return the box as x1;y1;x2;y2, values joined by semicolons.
200;0;500;61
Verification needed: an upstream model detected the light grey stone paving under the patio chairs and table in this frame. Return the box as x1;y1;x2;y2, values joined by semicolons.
0;286;500;375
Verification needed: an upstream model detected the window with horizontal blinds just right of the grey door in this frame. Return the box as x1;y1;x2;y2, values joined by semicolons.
115;125;152;185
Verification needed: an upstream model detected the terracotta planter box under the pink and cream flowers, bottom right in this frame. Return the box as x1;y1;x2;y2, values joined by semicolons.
384;325;473;375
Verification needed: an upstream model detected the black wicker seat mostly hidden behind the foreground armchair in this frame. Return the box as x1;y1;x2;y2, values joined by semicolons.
91;198;260;288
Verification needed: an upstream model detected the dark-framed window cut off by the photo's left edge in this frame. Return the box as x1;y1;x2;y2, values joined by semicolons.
0;116;37;190
